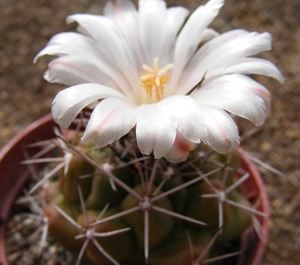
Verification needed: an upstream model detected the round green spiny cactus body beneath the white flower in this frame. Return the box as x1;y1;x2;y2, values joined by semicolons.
21;126;263;265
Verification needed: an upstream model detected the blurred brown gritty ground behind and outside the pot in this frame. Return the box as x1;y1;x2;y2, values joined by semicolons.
0;0;300;265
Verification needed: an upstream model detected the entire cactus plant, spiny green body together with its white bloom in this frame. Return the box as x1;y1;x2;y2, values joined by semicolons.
21;0;283;265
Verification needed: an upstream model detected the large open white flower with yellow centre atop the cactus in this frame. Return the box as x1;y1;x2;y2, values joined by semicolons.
35;0;283;162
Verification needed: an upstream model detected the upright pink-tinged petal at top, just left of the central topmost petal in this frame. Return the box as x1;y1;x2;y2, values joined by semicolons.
103;0;145;68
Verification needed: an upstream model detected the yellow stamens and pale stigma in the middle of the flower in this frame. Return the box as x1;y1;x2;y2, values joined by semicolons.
140;58;174;103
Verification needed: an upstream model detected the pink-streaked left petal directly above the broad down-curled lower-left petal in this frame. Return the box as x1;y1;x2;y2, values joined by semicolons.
44;56;118;89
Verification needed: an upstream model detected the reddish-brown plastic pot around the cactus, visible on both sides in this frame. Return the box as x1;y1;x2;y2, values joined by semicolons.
0;115;269;265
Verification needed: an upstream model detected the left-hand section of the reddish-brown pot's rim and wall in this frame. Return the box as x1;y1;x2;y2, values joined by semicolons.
0;115;56;265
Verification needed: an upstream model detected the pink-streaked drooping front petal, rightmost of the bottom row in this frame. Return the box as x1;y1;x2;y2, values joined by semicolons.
201;106;239;154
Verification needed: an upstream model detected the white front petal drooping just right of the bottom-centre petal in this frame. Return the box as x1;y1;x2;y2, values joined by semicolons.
156;95;207;143
